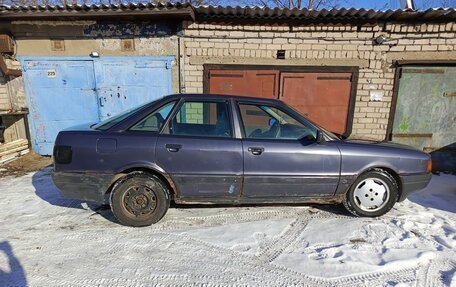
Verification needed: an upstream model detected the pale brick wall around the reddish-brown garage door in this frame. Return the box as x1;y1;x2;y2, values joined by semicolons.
180;22;456;140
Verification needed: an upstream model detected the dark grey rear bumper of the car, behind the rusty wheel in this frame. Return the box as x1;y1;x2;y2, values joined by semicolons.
52;172;113;203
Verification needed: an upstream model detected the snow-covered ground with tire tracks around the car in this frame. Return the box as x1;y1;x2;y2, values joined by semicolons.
0;168;456;286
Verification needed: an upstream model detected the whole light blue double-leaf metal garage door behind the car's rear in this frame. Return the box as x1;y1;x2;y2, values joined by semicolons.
21;57;173;155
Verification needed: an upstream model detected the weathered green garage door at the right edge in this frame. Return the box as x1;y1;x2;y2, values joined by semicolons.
392;66;456;171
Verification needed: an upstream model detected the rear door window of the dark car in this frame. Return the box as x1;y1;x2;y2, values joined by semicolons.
169;101;233;138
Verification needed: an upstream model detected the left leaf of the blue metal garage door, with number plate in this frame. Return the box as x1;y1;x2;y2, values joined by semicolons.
23;60;98;155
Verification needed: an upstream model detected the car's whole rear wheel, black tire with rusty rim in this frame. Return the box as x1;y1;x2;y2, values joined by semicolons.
110;172;170;227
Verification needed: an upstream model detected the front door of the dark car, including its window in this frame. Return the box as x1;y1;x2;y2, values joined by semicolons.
237;102;341;197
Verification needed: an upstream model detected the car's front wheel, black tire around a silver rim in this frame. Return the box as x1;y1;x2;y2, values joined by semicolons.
343;169;399;217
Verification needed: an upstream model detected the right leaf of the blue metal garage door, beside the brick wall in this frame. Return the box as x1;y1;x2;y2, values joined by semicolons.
95;57;173;120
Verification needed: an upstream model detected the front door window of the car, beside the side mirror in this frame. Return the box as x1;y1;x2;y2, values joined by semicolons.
239;104;317;140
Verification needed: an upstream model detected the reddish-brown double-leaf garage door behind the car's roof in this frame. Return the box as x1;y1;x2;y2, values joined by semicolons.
206;67;353;136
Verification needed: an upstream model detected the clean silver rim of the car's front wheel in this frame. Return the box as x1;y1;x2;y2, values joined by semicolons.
353;178;390;212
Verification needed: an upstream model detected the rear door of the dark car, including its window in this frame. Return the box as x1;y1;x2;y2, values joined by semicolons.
156;99;243;200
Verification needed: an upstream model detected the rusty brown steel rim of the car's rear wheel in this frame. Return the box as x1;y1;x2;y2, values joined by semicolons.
122;185;157;217
